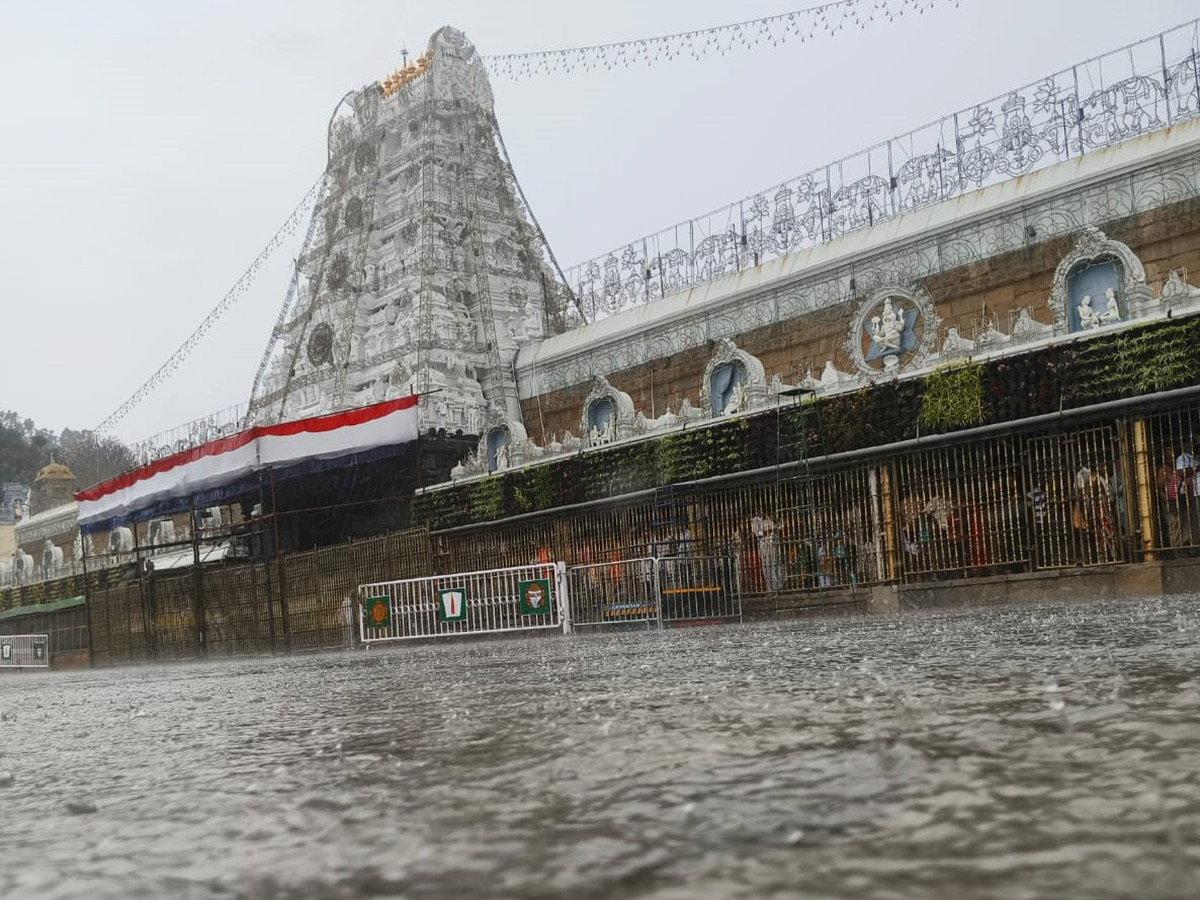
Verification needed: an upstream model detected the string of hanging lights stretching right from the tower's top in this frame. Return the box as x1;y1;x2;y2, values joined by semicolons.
484;0;961;80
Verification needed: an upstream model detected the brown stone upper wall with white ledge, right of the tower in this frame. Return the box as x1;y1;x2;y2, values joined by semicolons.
518;122;1200;446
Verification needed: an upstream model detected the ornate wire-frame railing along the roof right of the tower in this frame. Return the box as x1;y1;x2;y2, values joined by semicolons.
566;19;1200;322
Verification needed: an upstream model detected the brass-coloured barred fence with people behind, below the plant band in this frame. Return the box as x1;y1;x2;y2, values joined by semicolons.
433;402;1200;595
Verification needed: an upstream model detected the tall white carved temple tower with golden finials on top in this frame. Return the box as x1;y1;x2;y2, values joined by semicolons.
248;28;580;434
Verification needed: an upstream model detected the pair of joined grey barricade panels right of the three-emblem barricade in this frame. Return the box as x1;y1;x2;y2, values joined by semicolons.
568;556;742;629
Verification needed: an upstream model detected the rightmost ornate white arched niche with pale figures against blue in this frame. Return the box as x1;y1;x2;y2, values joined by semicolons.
1046;226;1156;334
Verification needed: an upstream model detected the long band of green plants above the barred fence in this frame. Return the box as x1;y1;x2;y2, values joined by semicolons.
414;317;1200;528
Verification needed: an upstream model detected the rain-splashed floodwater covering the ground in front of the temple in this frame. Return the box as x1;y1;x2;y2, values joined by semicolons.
0;598;1200;900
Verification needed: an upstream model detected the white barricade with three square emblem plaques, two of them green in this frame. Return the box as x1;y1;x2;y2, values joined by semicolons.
359;563;571;644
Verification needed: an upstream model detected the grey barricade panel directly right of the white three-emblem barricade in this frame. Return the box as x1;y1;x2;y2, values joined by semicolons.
566;557;662;628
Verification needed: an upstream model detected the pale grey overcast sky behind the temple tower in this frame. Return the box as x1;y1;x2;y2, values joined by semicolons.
0;0;1200;440
